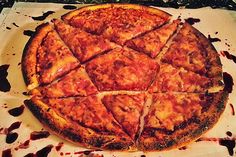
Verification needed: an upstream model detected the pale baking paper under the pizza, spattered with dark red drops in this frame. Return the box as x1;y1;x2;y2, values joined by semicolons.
0;2;236;157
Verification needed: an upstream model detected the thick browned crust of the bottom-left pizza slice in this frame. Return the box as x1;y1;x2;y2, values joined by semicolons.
24;97;136;151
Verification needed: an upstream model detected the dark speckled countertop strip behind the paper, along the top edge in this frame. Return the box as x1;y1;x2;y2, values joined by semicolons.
0;0;236;12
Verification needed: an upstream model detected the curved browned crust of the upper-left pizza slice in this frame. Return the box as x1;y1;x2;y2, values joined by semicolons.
21;23;52;90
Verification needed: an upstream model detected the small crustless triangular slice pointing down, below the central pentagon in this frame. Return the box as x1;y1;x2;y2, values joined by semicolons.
102;94;146;140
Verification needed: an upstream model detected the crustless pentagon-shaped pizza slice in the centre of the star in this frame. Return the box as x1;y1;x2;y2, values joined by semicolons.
85;48;159;91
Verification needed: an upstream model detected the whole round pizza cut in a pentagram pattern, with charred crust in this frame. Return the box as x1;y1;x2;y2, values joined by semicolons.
21;4;228;151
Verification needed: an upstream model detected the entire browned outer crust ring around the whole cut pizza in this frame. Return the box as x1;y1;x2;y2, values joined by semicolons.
22;4;228;151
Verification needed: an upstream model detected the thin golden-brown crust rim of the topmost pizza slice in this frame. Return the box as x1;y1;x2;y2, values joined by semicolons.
61;3;172;22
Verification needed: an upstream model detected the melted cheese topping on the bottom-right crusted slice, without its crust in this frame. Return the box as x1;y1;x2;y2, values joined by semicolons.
145;94;202;131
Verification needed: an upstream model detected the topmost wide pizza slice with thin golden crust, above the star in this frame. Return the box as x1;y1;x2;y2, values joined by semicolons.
62;4;171;39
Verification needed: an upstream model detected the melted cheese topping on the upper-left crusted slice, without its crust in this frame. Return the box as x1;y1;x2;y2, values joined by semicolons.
37;31;79;83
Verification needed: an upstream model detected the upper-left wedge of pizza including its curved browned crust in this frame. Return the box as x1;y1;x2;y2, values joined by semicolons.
22;23;80;89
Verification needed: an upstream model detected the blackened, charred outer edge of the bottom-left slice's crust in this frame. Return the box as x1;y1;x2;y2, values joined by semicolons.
24;99;136;151
